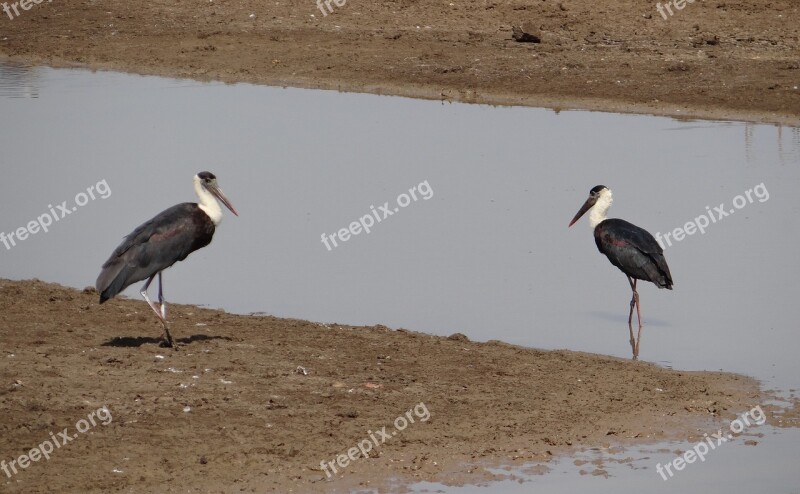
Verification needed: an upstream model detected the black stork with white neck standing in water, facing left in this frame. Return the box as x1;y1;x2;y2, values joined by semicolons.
569;185;672;360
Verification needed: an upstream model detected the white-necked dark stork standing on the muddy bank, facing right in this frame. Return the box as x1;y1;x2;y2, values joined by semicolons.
96;172;239;347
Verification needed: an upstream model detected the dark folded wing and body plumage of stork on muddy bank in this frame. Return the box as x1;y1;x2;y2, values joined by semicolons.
96;202;214;304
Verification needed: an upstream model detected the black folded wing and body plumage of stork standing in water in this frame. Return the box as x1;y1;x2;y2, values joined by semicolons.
594;219;672;290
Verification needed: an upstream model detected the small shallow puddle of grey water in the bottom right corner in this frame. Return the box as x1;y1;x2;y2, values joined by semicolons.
413;428;800;494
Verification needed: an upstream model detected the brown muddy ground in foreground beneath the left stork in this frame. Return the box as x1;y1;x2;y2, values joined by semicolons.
0;280;796;493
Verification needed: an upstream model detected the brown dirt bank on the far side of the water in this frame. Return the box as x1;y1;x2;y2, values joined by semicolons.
0;0;800;125
